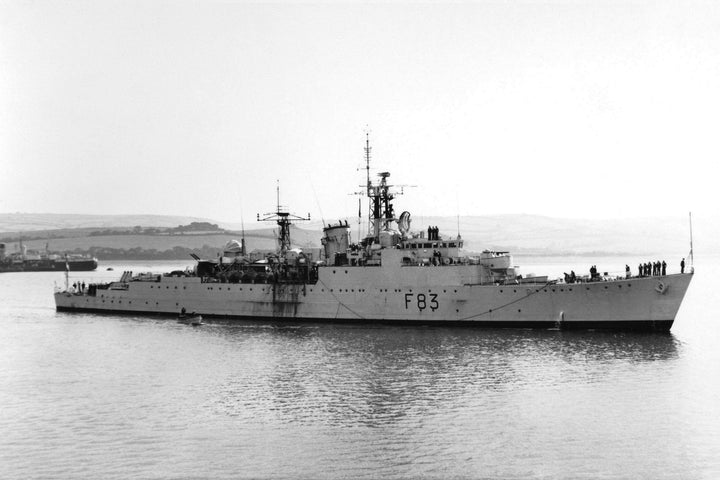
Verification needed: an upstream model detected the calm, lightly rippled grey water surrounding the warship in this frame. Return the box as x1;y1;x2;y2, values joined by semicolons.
0;258;720;479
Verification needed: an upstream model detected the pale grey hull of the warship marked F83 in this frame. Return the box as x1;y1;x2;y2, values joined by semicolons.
55;267;692;331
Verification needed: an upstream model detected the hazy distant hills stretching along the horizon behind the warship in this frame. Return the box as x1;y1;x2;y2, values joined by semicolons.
0;214;720;255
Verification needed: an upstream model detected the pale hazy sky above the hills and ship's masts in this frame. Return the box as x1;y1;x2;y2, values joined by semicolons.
0;0;720;222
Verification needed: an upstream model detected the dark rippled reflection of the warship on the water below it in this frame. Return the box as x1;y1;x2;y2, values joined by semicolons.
203;323;681;427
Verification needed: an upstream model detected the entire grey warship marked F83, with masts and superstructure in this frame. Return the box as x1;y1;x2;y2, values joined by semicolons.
54;138;693;331
